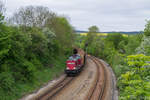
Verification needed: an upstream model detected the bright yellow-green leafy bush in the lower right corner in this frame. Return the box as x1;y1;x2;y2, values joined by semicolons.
118;54;150;100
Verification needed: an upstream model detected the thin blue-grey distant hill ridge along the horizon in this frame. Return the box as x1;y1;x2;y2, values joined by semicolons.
75;30;143;35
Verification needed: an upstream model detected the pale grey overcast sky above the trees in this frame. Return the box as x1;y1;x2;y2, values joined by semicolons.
2;0;150;31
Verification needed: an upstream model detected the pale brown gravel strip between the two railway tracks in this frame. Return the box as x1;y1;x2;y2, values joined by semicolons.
51;58;97;100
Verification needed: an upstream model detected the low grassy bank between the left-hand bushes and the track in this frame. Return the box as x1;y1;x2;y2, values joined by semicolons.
0;56;66;100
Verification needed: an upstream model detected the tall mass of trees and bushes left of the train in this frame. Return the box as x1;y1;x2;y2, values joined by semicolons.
0;2;74;100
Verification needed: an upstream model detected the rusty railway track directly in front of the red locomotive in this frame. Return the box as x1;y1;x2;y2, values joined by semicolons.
36;77;74;100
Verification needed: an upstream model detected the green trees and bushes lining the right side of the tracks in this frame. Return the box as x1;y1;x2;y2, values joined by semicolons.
76;21;150;100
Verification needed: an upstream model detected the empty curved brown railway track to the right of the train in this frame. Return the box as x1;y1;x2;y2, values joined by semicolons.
87;56;107;100
